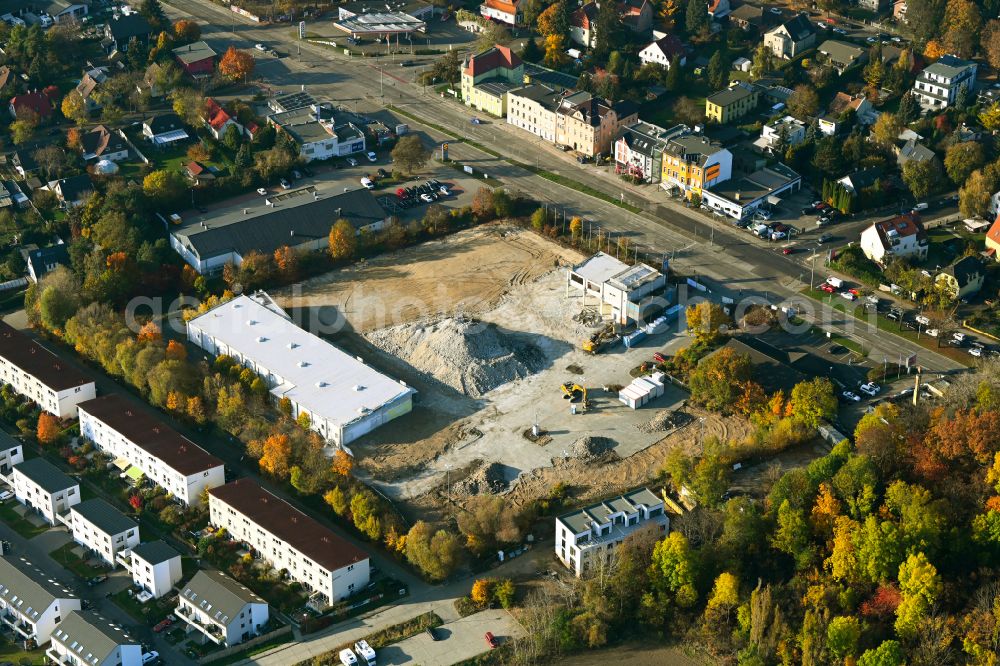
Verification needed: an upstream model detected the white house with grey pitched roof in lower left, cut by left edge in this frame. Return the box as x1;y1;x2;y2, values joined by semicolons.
0;557;80;645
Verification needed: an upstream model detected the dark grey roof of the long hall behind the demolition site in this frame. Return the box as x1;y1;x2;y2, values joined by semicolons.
173;186;388;261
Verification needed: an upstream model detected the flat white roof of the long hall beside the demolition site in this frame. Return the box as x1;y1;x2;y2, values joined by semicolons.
188;293;416;426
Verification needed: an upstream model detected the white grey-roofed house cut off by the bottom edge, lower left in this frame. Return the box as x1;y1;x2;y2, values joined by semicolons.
45;610;147;666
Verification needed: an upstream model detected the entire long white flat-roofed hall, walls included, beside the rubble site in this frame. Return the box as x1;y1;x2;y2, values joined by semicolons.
187;292;414;446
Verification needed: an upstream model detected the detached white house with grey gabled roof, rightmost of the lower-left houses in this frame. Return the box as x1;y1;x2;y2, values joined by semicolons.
176;570;269;647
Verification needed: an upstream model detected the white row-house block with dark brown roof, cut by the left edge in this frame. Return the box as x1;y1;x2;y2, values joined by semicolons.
0;321;96;419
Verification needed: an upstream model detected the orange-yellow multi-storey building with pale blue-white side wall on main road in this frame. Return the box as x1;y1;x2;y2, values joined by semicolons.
660;133;733;199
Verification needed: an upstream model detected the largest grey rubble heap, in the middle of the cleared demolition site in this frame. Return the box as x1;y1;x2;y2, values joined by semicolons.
367;318;545;398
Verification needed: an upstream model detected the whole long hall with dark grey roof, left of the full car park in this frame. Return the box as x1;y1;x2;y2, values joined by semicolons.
170;185;389;275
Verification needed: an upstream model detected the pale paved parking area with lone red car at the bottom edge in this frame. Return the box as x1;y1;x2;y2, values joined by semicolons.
377;610;524;666
